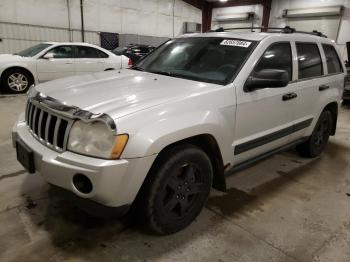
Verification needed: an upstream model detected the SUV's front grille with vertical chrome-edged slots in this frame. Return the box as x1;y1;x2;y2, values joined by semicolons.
25;100;73;152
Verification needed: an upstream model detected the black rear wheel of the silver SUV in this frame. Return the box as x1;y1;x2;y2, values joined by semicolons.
297;110;334;158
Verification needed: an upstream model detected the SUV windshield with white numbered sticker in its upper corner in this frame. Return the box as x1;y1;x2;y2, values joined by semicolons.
132;37;255;85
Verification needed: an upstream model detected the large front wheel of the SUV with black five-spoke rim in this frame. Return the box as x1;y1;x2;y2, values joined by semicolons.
138;144;213;234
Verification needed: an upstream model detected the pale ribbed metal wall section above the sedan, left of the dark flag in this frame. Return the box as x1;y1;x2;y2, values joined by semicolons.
0;22;100;53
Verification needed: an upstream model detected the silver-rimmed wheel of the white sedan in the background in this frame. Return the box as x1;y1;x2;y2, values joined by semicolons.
1;68;34;94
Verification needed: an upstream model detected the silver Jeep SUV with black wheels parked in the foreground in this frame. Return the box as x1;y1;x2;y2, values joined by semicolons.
13;29;345;234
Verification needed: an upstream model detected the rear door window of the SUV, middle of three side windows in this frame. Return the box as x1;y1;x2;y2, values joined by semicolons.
296;43;323;79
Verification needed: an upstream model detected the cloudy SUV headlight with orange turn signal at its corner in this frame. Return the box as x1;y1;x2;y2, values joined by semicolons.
67;121;128;159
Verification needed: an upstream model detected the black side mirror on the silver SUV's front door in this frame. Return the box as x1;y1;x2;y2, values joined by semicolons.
244;69;289;92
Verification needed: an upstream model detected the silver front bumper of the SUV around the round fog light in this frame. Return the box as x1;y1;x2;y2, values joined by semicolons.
12;121;156;207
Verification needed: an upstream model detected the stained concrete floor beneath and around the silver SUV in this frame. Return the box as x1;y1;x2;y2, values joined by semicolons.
0;96;350;262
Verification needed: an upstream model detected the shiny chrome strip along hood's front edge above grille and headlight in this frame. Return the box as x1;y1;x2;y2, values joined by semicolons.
28;87;117;134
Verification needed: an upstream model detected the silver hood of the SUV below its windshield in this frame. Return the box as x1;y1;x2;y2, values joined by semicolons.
36;70;218;119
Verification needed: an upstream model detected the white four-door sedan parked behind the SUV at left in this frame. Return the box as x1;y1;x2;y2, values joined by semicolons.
0;42;129;93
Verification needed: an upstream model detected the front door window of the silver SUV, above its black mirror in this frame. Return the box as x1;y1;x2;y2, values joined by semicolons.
254;43;292;80
